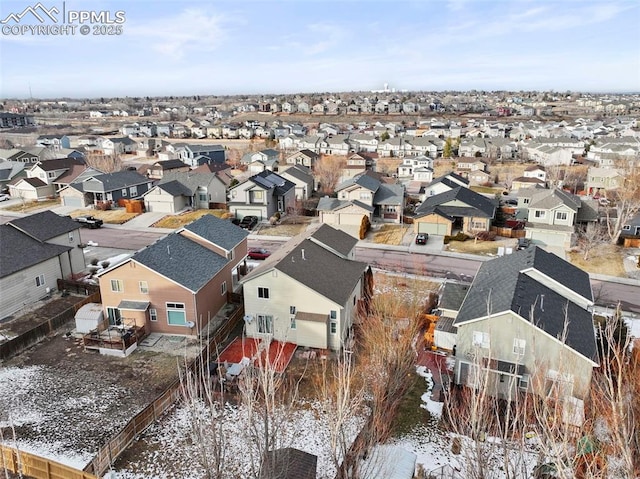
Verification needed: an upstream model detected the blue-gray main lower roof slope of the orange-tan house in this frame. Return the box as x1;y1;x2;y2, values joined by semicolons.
131;233;228;292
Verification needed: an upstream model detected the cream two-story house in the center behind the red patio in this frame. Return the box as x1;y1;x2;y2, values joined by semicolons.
242;225;373;350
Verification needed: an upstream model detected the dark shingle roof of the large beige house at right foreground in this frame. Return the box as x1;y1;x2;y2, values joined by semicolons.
454;246;597;361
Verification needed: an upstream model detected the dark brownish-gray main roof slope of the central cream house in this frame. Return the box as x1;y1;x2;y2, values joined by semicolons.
275;239;368;305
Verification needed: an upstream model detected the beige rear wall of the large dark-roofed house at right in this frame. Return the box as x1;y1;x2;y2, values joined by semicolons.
456;312;593;399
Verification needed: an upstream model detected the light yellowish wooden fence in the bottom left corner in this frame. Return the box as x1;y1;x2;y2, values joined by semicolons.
0;445;99;479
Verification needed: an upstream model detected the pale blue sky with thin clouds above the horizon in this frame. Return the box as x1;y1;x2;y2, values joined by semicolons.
0;0;640;98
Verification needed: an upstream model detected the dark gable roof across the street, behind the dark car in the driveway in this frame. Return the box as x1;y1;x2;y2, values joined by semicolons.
415;186;497;218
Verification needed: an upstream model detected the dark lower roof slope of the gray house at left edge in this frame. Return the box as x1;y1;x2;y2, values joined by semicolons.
0;226;71;285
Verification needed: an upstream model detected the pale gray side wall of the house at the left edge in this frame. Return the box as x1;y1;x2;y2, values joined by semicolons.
0;256;63;318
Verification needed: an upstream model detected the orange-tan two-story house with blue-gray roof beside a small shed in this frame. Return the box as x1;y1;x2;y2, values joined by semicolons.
100;215;248;335
